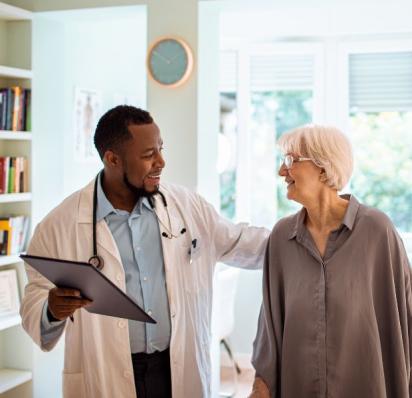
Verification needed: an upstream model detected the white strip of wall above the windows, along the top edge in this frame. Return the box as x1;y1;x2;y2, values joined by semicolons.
221;0;412;40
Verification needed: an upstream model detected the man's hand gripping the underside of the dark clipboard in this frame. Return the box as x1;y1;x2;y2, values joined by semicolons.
48;287;92;321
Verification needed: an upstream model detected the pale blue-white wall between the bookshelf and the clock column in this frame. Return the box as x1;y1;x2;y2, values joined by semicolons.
33;6;147;398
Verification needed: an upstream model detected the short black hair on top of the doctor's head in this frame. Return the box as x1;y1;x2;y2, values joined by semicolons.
94;105;153;160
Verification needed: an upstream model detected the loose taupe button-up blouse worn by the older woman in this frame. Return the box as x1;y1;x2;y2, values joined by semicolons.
252;196;412;398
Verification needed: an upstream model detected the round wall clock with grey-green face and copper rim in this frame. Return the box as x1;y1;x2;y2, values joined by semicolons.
148;39;192;87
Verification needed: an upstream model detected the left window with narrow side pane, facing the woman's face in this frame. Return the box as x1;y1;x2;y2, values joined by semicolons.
219;45;316;228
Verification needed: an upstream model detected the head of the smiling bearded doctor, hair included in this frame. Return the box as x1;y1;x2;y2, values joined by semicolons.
94;105;165;199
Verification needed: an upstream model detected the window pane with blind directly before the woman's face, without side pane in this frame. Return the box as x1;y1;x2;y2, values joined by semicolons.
250;54;314;226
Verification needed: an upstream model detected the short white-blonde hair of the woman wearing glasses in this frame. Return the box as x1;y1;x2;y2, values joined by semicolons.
277;124;353;191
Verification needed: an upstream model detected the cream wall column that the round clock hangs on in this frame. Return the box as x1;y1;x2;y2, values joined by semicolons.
147;0;198;190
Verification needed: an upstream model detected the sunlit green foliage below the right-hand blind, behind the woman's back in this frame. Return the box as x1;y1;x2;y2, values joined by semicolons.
350;112;412;232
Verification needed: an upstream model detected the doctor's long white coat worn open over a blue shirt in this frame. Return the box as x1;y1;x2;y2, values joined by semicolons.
21;182;269;398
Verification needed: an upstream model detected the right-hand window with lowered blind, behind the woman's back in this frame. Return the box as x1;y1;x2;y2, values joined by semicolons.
349;51;412;233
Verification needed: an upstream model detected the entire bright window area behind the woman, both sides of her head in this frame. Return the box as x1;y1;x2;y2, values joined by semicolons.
221;38;412;262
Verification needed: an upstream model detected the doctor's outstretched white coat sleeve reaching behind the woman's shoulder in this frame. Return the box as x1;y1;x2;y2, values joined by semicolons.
199;196;270;269
